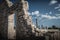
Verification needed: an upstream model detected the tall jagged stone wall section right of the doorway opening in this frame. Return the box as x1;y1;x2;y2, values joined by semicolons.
16;0;32;39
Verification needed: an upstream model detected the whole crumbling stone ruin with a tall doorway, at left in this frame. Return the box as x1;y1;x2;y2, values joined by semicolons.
0;0;32;39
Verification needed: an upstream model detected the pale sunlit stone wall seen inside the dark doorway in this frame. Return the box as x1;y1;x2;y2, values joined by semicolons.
8;14;16;39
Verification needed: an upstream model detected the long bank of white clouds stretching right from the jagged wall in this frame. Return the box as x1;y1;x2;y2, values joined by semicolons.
29;11;60;20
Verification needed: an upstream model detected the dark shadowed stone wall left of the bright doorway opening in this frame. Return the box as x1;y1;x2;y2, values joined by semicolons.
0;0;8;40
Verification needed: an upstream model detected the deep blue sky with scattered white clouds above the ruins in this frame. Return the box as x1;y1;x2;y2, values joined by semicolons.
0;0;60;27
